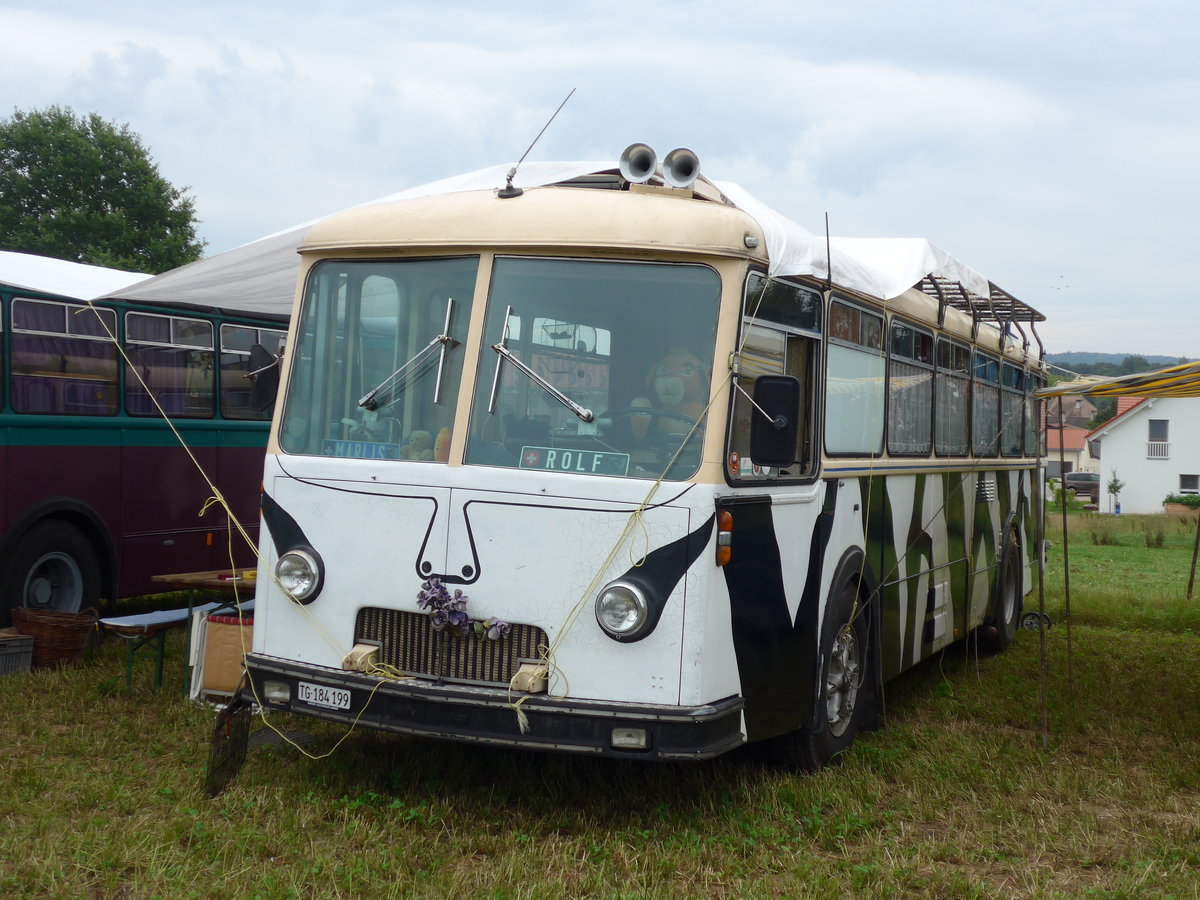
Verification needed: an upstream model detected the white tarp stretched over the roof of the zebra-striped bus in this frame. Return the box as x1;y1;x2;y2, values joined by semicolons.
109;162;1003;317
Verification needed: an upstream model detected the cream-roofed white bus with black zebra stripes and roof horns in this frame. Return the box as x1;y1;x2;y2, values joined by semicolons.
239;148;1044;768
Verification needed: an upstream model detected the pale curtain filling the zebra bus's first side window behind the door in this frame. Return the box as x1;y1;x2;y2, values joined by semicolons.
826;345;883;455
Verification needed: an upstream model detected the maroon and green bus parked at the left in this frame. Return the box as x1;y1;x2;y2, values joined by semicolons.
0;254;287;625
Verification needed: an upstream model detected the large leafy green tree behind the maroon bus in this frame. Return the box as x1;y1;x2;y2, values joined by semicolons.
0;106;204;274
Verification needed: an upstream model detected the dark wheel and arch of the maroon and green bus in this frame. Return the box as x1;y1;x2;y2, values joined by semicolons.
0;521;100;624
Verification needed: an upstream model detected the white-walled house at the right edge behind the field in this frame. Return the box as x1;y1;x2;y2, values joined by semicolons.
1087;397;1200;512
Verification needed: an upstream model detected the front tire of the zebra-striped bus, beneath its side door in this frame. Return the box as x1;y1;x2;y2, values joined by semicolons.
764;582;872;772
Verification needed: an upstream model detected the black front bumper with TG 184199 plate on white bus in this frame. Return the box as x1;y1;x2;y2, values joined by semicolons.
242;654;744;760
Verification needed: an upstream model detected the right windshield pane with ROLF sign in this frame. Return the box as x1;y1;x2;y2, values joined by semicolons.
466;258;720;480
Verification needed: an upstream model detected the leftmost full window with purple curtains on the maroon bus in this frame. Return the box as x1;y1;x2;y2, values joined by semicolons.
11;331;118;415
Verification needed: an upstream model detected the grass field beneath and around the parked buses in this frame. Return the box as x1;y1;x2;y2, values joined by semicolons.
0;516;1200;899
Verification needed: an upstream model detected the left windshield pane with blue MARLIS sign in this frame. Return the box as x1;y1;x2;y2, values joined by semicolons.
280;257;479;462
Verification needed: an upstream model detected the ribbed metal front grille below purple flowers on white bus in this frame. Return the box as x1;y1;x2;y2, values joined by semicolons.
354;606;550;684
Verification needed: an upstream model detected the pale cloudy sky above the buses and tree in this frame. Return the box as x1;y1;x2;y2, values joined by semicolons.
0;0;1200;358
